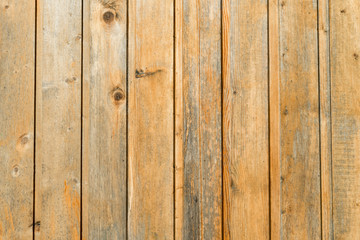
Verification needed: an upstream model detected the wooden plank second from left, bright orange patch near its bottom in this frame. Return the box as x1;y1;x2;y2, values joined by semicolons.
35;0;81;239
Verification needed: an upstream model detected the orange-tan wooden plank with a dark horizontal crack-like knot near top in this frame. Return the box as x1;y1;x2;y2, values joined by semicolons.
128;0;174;239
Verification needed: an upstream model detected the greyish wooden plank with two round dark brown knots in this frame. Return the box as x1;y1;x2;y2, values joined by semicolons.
82;0;127;240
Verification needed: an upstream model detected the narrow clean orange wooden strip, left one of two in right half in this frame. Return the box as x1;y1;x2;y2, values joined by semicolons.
268;0;281;239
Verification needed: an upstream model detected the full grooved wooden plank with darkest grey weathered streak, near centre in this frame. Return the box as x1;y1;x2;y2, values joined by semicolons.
175;0;222;239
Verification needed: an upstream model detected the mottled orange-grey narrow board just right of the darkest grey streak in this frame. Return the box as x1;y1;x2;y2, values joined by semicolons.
199;0;222;239
